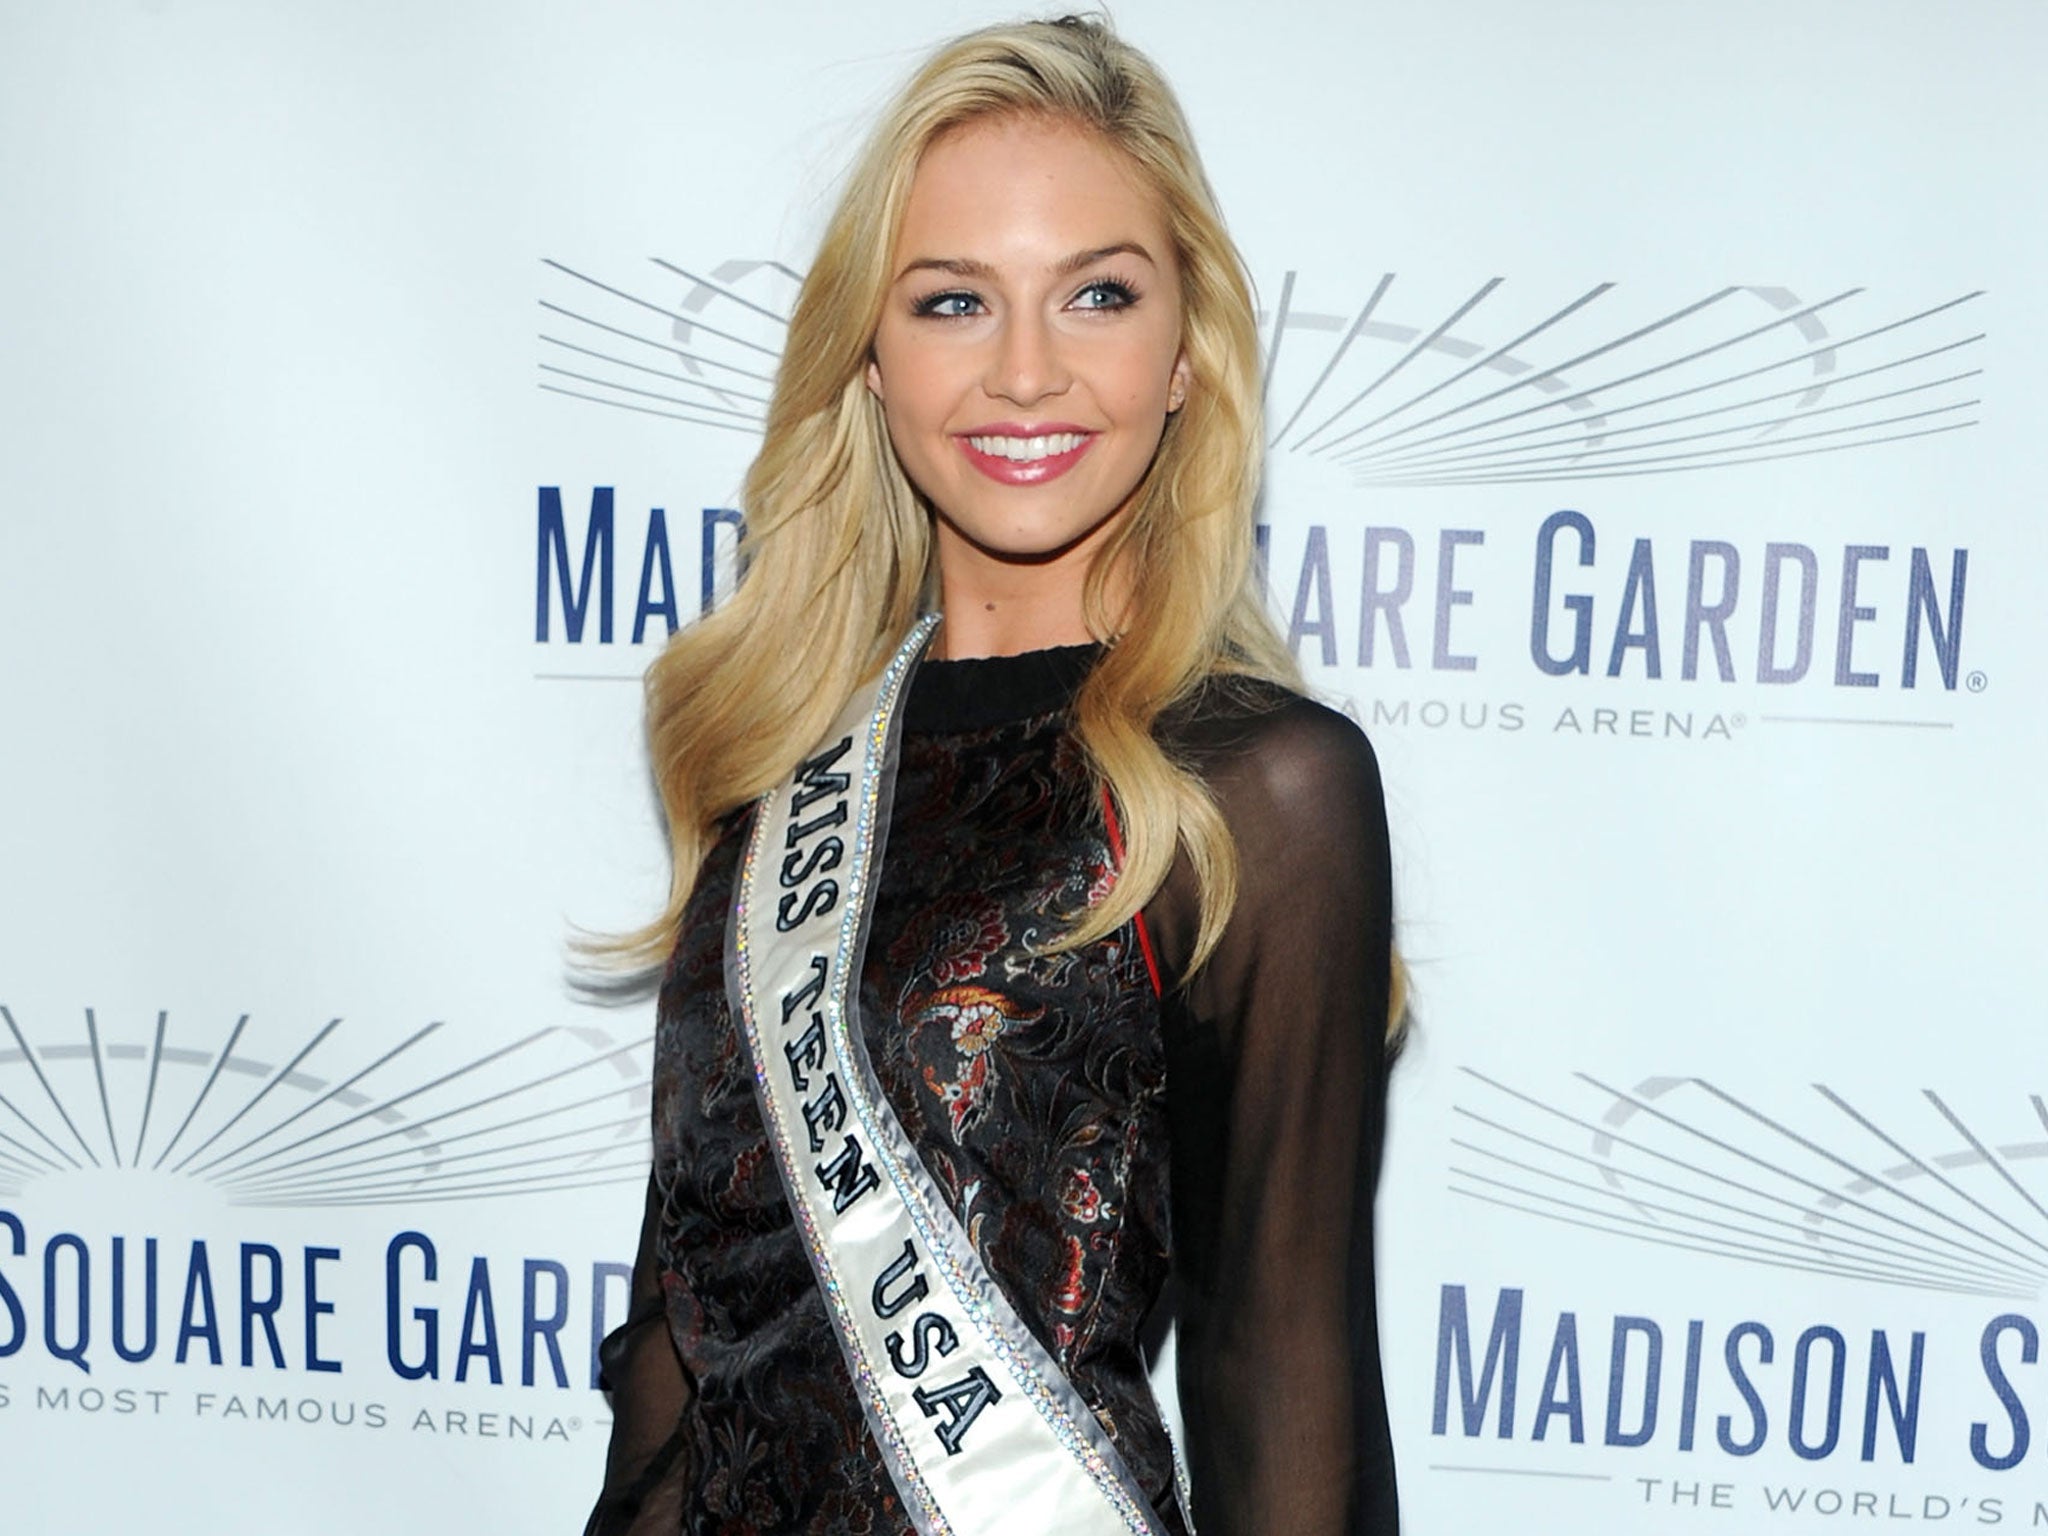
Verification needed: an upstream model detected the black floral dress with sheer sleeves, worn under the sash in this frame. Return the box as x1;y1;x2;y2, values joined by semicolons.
590;647;1397;1536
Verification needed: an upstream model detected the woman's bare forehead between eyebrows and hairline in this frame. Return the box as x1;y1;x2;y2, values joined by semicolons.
897;117;1171;266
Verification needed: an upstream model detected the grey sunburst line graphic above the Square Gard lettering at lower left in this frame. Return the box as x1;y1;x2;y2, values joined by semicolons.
0;1006;653;1206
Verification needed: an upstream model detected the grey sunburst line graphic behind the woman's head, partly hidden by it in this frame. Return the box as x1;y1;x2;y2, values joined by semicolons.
539;258;1985;485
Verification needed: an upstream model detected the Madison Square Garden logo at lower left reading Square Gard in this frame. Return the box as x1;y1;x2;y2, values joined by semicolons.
0;1006;653;1440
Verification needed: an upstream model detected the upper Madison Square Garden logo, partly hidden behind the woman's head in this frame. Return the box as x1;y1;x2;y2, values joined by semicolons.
522;258;1989;741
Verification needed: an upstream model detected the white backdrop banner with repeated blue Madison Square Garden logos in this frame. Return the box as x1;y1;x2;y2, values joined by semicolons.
0;0;2048;1536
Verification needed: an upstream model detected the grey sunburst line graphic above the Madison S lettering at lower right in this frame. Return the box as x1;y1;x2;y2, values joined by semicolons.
1450;1067;2048;1298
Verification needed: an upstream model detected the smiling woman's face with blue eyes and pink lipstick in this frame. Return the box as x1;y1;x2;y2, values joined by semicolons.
868;119;1188;626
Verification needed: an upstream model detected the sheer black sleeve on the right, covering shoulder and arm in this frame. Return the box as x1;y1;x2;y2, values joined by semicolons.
1147;690;1399;1536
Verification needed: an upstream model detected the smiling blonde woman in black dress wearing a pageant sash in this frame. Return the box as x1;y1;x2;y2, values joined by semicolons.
590;18;1399;1536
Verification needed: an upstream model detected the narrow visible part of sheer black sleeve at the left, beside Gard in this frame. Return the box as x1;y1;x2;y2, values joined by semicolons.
584;1178;690;1536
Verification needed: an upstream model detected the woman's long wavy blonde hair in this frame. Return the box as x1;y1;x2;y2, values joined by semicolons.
616;16;1401;1040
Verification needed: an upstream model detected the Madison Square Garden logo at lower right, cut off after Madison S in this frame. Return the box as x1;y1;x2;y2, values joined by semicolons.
1430;1067;2048;1530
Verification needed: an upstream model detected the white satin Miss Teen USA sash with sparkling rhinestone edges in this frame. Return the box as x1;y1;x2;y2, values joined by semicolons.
725;614;1161;1536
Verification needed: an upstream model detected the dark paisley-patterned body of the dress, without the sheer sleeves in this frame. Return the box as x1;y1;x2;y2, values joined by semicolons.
655;700;1184;1536
